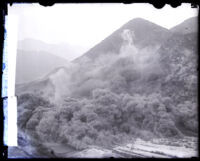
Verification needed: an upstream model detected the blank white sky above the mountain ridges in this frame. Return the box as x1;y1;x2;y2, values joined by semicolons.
8;3;198;49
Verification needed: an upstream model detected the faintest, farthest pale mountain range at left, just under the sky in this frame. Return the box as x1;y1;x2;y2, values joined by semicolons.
18;39;87;61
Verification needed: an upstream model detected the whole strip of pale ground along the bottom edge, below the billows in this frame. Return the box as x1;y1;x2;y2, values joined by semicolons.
8;137;198;158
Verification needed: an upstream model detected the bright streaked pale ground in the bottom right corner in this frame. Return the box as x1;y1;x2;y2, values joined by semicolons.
114;137;198;158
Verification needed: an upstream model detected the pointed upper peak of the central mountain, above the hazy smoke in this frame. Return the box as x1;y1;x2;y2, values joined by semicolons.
74;18;171;63
